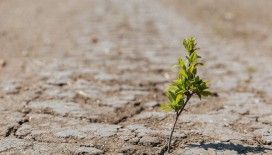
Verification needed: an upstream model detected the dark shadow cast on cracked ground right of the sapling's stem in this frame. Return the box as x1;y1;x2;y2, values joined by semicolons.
189;143;272;154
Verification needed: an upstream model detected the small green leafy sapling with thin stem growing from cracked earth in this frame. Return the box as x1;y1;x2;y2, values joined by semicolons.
161;37;212;153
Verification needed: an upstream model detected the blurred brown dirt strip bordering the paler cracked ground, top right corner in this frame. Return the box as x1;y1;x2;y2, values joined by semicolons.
163;0;272;54
